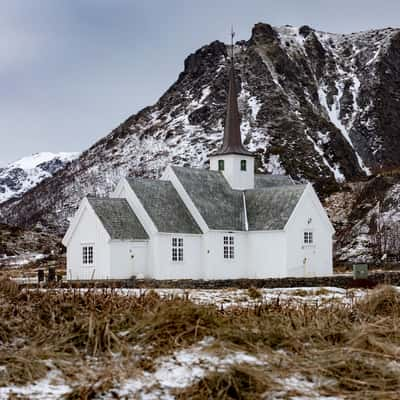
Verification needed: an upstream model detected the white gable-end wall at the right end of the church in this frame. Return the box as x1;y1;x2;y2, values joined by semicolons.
286;186;333;276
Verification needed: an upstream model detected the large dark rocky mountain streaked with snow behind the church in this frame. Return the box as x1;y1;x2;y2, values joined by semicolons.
0;23;400;260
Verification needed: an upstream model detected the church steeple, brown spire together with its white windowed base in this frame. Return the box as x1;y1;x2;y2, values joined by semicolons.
210;58;254;190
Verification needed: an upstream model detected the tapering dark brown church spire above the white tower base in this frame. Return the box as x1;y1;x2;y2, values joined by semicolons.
217;29;251;155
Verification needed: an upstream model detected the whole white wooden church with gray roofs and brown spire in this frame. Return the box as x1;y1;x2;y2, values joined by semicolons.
63;61;334;280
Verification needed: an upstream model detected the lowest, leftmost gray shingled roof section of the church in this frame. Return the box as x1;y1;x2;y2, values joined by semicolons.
87;197;149;240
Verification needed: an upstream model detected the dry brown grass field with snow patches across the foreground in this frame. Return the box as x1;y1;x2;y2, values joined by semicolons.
0;279;400;400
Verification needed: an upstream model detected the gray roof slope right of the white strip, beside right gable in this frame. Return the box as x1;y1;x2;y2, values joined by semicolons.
245;184;306;231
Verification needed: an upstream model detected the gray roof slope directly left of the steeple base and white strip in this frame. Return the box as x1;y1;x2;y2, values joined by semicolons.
172;166;245;231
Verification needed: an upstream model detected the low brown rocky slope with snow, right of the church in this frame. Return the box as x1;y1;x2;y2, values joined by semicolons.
325;169;400;264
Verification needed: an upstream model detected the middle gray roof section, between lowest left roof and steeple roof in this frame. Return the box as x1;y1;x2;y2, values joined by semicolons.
127;178;201;234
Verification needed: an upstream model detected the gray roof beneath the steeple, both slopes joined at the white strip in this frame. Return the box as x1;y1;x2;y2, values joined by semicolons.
171;166;306;231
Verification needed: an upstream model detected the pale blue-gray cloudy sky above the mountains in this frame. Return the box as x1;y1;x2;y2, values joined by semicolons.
0;0;400;165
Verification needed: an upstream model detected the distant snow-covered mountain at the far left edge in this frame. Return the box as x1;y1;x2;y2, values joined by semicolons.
0;152;79;203
